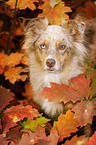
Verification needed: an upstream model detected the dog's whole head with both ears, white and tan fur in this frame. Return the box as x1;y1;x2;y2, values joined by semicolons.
23;18;84;72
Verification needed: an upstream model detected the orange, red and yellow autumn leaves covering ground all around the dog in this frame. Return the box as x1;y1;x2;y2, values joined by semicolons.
0;0;96;145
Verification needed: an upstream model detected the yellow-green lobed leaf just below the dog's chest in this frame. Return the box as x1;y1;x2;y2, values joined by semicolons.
21;116;49;132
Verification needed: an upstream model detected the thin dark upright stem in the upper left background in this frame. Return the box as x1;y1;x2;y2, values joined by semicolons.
5;0;18;55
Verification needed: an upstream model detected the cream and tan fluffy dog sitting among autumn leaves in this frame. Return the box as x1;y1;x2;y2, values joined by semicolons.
23;18;87;117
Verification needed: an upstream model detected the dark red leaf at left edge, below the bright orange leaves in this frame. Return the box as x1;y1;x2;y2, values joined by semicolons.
0;86;14;112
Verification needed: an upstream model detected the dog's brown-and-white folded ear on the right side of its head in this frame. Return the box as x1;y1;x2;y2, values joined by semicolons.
61;20;85;36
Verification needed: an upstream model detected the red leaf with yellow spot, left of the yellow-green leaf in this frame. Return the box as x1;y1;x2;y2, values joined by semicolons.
5;104;40;122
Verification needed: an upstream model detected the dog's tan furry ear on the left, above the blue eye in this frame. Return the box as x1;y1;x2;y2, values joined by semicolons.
22;17;48;53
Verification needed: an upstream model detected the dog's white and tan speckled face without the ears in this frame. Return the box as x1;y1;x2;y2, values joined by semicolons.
34;25;72;72
